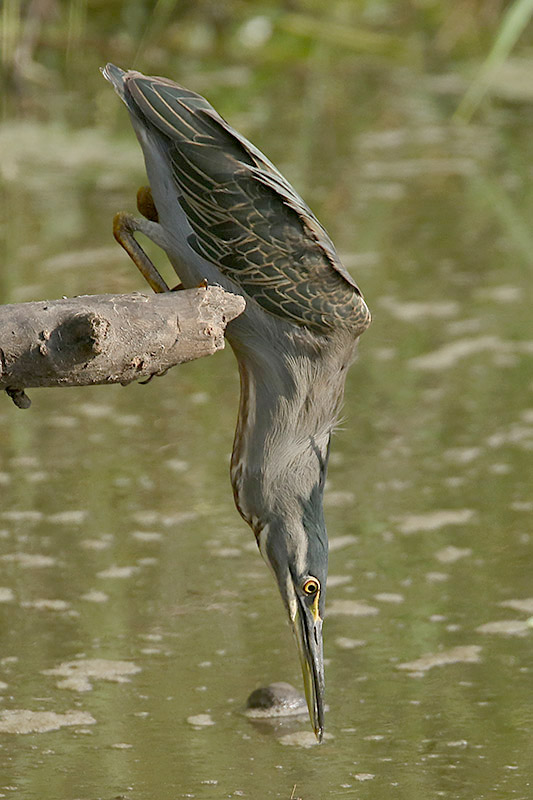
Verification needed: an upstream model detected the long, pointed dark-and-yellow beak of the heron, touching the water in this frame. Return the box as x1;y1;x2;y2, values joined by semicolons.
291;600;324;742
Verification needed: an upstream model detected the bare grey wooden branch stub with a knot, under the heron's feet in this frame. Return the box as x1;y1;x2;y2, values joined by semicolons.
0;286;245;408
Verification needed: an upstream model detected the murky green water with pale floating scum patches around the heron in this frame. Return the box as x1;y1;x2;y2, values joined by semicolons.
0;31;533;800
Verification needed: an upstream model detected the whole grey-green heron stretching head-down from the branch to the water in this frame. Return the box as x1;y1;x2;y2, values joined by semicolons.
103;64;370;741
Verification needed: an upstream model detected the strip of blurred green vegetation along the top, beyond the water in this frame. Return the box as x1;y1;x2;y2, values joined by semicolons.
0;0;533;125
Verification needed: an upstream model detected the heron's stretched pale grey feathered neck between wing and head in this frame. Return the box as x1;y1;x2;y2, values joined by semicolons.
231;332;353;532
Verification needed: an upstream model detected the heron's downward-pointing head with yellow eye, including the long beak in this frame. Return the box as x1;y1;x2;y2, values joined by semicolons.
259;500;328;742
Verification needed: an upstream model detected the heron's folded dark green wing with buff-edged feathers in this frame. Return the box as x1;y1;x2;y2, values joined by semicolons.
125;73;370;334
